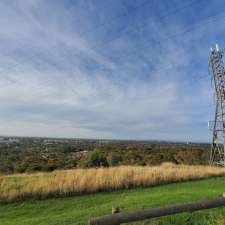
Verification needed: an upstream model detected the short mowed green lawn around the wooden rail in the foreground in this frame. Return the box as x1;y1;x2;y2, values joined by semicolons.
0;177;225;225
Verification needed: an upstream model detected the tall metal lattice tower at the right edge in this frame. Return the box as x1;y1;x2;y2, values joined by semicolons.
209;45;225;166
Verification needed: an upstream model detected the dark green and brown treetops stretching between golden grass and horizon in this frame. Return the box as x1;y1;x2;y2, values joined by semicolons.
0;138;210;174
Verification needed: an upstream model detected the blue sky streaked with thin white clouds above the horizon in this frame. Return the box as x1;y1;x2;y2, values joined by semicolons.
0;0;225;142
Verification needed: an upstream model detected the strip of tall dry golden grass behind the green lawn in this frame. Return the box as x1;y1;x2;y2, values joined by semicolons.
0;163;225;202
